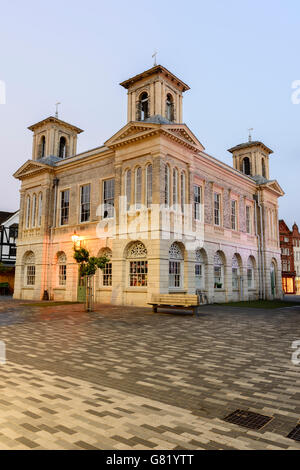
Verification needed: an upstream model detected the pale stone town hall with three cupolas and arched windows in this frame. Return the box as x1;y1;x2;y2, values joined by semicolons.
14;65;284;306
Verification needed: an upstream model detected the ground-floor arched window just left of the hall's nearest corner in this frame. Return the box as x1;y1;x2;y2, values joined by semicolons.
127;242;148;287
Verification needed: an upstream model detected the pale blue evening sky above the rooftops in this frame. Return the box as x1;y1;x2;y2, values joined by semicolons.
0;0;300;226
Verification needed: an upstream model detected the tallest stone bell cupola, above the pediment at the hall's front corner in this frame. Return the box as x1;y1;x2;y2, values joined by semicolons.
120;65;190;124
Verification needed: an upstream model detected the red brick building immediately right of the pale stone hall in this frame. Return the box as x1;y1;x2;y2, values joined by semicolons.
279;220;296;294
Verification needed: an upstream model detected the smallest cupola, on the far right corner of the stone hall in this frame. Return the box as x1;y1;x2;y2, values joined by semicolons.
228;136;273;180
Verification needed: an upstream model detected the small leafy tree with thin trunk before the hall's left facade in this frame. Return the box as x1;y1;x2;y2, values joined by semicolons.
74;248;109;312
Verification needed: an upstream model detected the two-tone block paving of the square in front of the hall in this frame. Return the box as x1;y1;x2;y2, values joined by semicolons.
0;298;300;450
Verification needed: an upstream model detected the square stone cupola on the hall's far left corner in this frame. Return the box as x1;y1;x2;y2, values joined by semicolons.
28;116;83;160
